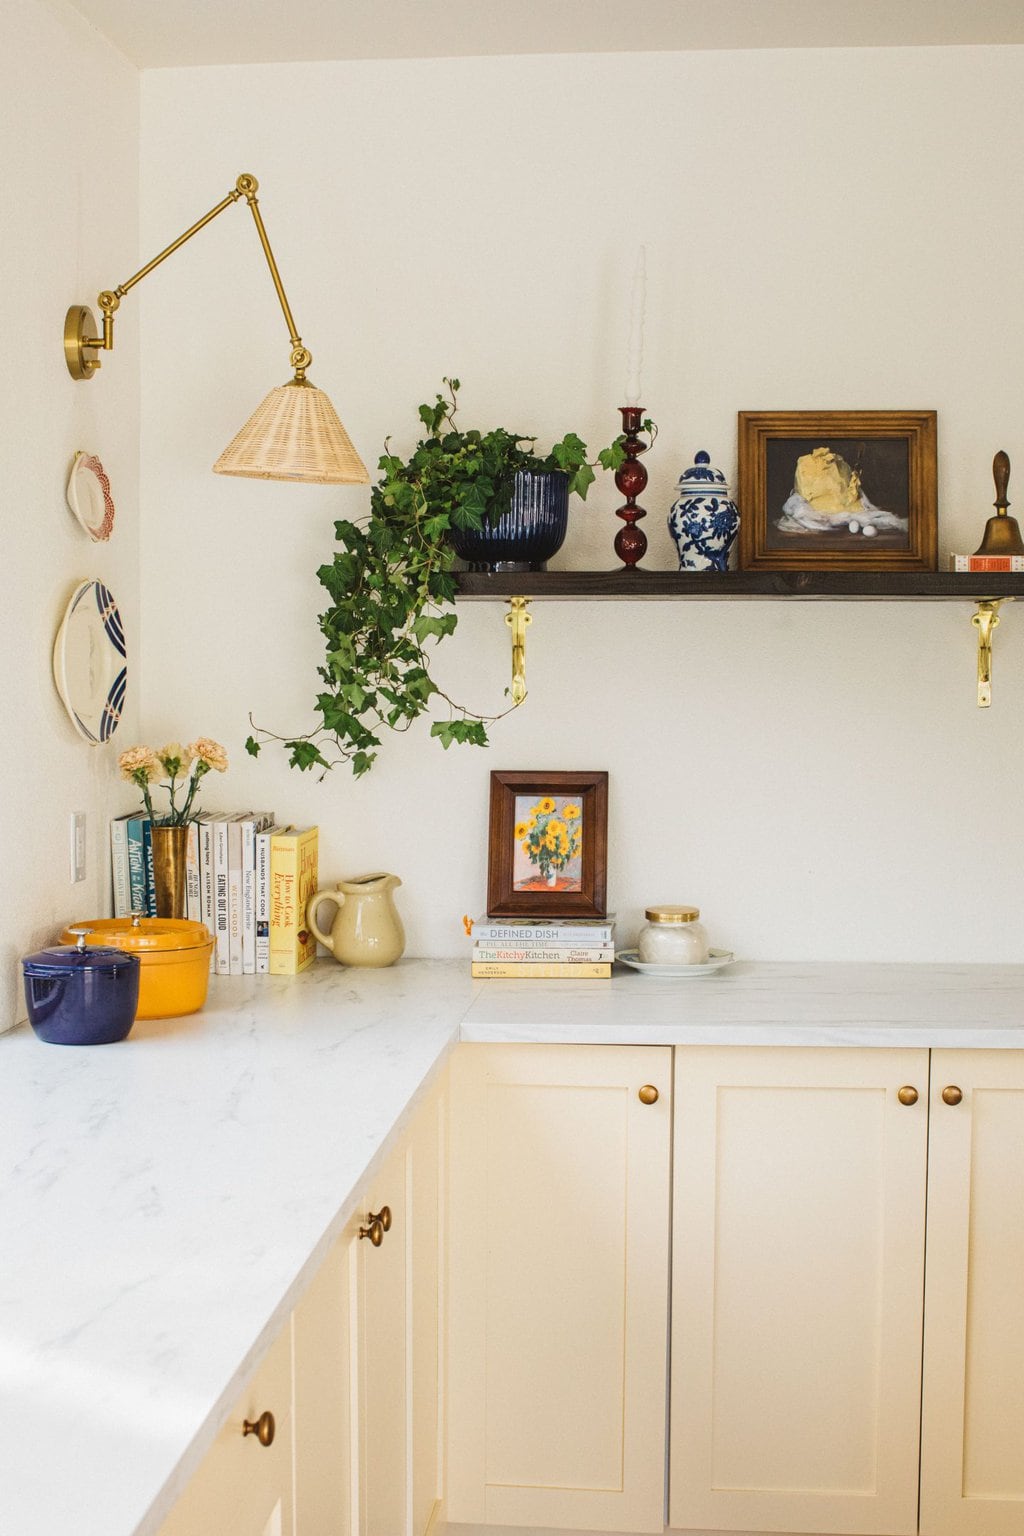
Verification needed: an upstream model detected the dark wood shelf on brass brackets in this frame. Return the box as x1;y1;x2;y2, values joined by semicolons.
457;570;1024;602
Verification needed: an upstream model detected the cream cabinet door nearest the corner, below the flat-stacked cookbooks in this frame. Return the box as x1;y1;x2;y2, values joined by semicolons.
448;1044;671;1531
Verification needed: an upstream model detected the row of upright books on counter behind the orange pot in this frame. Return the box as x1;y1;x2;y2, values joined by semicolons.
111;811;319;975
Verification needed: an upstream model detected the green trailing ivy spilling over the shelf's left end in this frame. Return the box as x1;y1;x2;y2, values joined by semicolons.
246;378;656;777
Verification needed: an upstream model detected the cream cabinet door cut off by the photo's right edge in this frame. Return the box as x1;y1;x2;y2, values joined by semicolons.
921;1051;1024;1536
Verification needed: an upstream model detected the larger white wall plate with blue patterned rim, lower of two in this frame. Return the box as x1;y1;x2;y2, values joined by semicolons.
54;581;127;745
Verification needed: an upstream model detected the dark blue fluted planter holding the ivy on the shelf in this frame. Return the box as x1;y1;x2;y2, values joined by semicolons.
451;470;570;571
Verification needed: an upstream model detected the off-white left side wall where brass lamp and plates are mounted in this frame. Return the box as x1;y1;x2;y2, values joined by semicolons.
0;0;138;1029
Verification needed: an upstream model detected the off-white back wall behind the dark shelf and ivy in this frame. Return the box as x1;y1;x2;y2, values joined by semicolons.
140;48;1024;960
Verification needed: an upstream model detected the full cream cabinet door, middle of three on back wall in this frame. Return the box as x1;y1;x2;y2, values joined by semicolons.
669;1046;927;1533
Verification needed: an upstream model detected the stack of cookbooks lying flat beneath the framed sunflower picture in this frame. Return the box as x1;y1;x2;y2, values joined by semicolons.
473;915;616;982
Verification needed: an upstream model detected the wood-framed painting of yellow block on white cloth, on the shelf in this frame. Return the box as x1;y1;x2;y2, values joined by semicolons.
738;410;938;571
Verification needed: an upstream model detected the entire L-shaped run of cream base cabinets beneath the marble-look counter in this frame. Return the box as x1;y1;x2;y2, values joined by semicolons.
150;1044;1024;1536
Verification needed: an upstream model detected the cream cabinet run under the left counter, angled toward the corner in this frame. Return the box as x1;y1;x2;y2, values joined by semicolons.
160;1086;447;1536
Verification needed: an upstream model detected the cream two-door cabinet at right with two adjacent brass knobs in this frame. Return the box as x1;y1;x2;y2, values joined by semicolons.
669;1048;1024;1536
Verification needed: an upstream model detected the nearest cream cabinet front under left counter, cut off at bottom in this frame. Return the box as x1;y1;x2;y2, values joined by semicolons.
160;1326;293;1536
